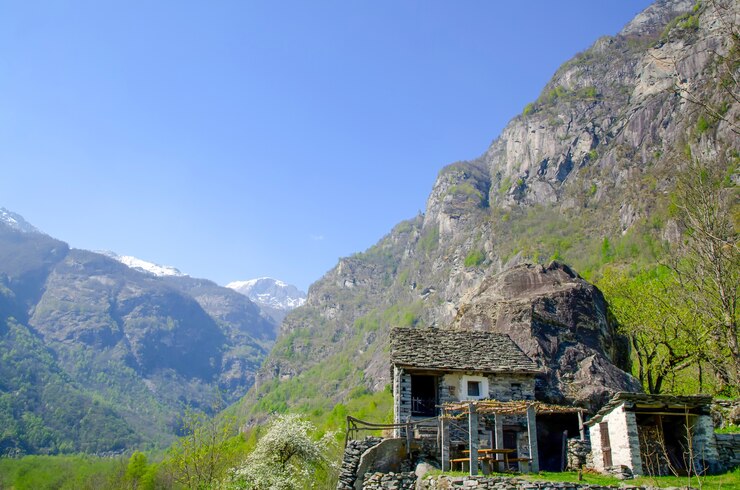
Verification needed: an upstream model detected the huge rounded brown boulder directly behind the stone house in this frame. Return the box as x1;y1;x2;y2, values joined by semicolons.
454;262;642;409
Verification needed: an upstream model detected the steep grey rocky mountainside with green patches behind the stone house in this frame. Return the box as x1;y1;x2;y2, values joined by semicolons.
240;0;740;419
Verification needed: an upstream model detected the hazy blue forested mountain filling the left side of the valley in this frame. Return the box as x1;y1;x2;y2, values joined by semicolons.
0;216;277;454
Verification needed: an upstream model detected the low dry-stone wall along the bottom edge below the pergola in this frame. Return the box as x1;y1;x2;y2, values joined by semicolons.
420;476;644;490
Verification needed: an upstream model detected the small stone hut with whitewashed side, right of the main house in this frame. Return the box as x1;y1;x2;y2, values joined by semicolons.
584;393;721;476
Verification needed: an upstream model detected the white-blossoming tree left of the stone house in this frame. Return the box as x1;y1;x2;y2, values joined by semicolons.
229;414;335;490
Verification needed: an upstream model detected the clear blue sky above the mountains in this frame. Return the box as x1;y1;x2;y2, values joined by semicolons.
0;0;650;289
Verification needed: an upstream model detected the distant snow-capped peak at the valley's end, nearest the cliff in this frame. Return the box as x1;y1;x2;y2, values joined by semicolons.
226;277;306;324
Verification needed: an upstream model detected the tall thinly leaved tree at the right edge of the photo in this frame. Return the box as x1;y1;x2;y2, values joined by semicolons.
669;161;740;394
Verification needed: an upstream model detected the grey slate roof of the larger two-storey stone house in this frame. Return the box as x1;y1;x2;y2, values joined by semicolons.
390;328;540;373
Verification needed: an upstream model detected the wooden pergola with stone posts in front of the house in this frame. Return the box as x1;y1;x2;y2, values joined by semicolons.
439;400;585;475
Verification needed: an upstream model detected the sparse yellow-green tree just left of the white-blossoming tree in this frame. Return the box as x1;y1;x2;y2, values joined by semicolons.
166;409;237;489
